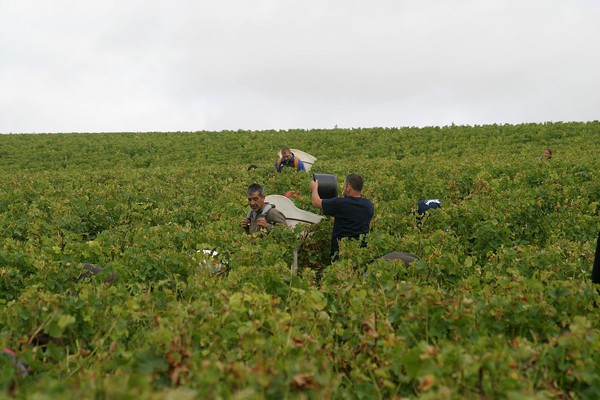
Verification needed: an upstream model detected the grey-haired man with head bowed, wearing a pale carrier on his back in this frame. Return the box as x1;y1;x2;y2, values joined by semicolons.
242;183;286;233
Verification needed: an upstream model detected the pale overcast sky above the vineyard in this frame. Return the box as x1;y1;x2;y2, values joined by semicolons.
0;0;600;133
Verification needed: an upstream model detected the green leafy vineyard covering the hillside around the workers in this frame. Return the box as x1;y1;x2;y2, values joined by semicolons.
0;122;600;399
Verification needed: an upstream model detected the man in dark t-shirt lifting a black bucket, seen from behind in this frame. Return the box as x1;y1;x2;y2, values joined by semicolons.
309;174;374;261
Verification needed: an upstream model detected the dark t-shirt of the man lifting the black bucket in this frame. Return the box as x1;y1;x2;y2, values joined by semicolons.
322;197;374;256
